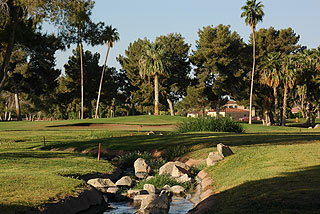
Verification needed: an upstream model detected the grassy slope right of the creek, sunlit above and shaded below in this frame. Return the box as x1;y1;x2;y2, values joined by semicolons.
204;141;320;213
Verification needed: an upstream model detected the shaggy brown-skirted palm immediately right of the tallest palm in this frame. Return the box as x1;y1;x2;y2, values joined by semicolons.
260;52;281;122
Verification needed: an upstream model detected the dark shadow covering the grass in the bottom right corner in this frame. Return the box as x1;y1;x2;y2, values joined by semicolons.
191;166;320;214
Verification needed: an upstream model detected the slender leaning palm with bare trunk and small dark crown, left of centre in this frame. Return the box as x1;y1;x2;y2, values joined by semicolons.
94;26;120;119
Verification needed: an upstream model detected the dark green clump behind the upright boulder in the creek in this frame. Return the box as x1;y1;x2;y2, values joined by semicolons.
118;151;165;171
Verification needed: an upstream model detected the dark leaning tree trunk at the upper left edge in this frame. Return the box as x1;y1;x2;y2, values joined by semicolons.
0;7;19;92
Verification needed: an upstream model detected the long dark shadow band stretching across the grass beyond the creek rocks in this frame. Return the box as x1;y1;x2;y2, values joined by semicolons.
42;132;320;152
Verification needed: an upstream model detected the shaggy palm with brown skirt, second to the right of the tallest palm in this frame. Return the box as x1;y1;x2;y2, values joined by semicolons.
281;55;297;126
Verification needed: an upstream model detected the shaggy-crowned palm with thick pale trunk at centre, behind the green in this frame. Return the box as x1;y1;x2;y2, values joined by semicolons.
139;42;166;115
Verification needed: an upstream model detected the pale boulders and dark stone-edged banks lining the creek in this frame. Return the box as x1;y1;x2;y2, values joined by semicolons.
38;144;233;214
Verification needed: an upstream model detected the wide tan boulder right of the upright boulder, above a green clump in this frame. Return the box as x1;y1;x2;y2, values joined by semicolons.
159;161;190;177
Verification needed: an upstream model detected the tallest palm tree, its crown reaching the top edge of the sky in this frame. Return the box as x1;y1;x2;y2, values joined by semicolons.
241;0;264;124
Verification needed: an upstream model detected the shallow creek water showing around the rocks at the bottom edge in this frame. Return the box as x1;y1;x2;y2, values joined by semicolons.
104;197;193;214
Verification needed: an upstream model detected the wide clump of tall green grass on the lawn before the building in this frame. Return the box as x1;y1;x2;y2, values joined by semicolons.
177;117;245;133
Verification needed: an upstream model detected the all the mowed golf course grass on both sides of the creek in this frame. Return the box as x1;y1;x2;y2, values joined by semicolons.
0;116;320;213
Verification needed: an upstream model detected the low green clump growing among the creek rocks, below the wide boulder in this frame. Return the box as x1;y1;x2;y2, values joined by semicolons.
135;175;191;190
